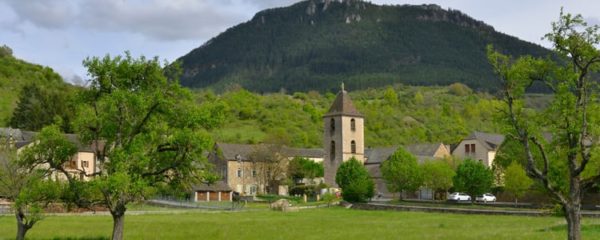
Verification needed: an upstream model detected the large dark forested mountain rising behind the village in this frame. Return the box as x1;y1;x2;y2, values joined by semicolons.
179;0;550;92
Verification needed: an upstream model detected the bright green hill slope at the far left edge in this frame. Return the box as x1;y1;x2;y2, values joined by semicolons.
0;45;70;127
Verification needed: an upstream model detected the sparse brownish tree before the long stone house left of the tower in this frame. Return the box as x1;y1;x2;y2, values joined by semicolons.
250;144;288;194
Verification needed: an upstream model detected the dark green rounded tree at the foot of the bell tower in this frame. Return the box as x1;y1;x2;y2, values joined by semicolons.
335;157;375;202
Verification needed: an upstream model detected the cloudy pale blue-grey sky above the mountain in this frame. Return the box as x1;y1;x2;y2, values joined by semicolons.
0;0;600;82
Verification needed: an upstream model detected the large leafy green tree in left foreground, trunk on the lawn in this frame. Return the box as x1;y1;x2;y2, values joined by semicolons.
75;52;214;240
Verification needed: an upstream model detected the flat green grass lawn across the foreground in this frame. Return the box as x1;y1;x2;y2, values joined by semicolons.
0;207;600;240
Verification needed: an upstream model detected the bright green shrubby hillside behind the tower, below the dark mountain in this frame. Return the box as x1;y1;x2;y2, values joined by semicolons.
197;84;506;147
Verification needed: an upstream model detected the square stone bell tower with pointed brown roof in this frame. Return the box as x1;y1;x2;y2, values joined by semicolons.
323;83;365;187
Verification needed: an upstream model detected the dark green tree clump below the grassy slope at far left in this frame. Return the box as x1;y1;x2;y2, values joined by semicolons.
9;83;75;132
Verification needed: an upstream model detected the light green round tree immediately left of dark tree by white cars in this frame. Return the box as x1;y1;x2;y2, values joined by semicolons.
421;160;456;199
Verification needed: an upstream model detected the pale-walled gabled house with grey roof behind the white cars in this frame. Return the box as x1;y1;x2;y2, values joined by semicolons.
452;132;505;168
